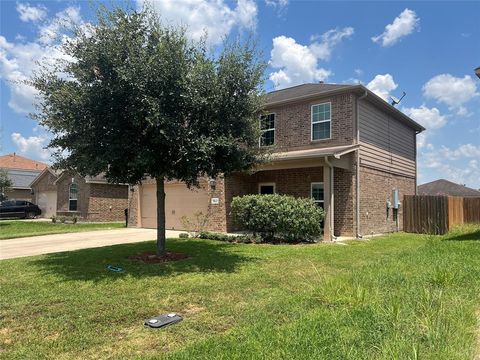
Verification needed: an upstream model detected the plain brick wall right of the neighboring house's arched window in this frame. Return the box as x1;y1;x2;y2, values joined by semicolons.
88;183;128;221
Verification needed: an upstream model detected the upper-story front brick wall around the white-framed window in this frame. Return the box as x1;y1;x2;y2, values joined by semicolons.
267;94;355;151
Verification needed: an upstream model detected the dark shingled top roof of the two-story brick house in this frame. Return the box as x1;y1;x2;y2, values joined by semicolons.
265;83;425;132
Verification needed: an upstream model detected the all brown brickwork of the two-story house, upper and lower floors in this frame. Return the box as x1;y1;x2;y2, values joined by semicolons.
128;86;416;237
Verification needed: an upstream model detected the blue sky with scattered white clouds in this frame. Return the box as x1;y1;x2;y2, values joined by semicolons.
0;0;480;189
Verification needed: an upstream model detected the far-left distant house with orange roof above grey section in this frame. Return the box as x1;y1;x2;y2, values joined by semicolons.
0;153;48;201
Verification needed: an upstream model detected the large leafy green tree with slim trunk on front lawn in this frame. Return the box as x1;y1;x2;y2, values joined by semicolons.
31;8;265;255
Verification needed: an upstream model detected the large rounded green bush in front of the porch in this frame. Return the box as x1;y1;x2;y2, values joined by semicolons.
232;194;324;242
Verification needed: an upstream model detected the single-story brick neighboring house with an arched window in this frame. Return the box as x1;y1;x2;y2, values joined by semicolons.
31;168;128;221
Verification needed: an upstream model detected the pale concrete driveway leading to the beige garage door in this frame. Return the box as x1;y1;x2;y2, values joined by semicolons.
0;228;186;260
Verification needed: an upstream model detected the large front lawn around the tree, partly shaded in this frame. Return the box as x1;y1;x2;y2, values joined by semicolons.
0;226;480;360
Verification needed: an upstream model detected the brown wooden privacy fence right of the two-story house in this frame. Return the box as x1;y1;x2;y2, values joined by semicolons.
403;195;480;235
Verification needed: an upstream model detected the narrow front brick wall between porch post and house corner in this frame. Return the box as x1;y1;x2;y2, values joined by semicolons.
333;168;356;236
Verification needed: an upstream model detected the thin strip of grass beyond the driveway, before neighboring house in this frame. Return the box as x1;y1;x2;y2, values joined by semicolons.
0;220;125;240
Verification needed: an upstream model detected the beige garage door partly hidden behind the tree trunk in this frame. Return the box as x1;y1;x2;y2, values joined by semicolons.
140;184;210;230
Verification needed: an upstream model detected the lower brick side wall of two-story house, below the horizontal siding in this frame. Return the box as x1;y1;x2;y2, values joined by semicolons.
360;167;415;236
